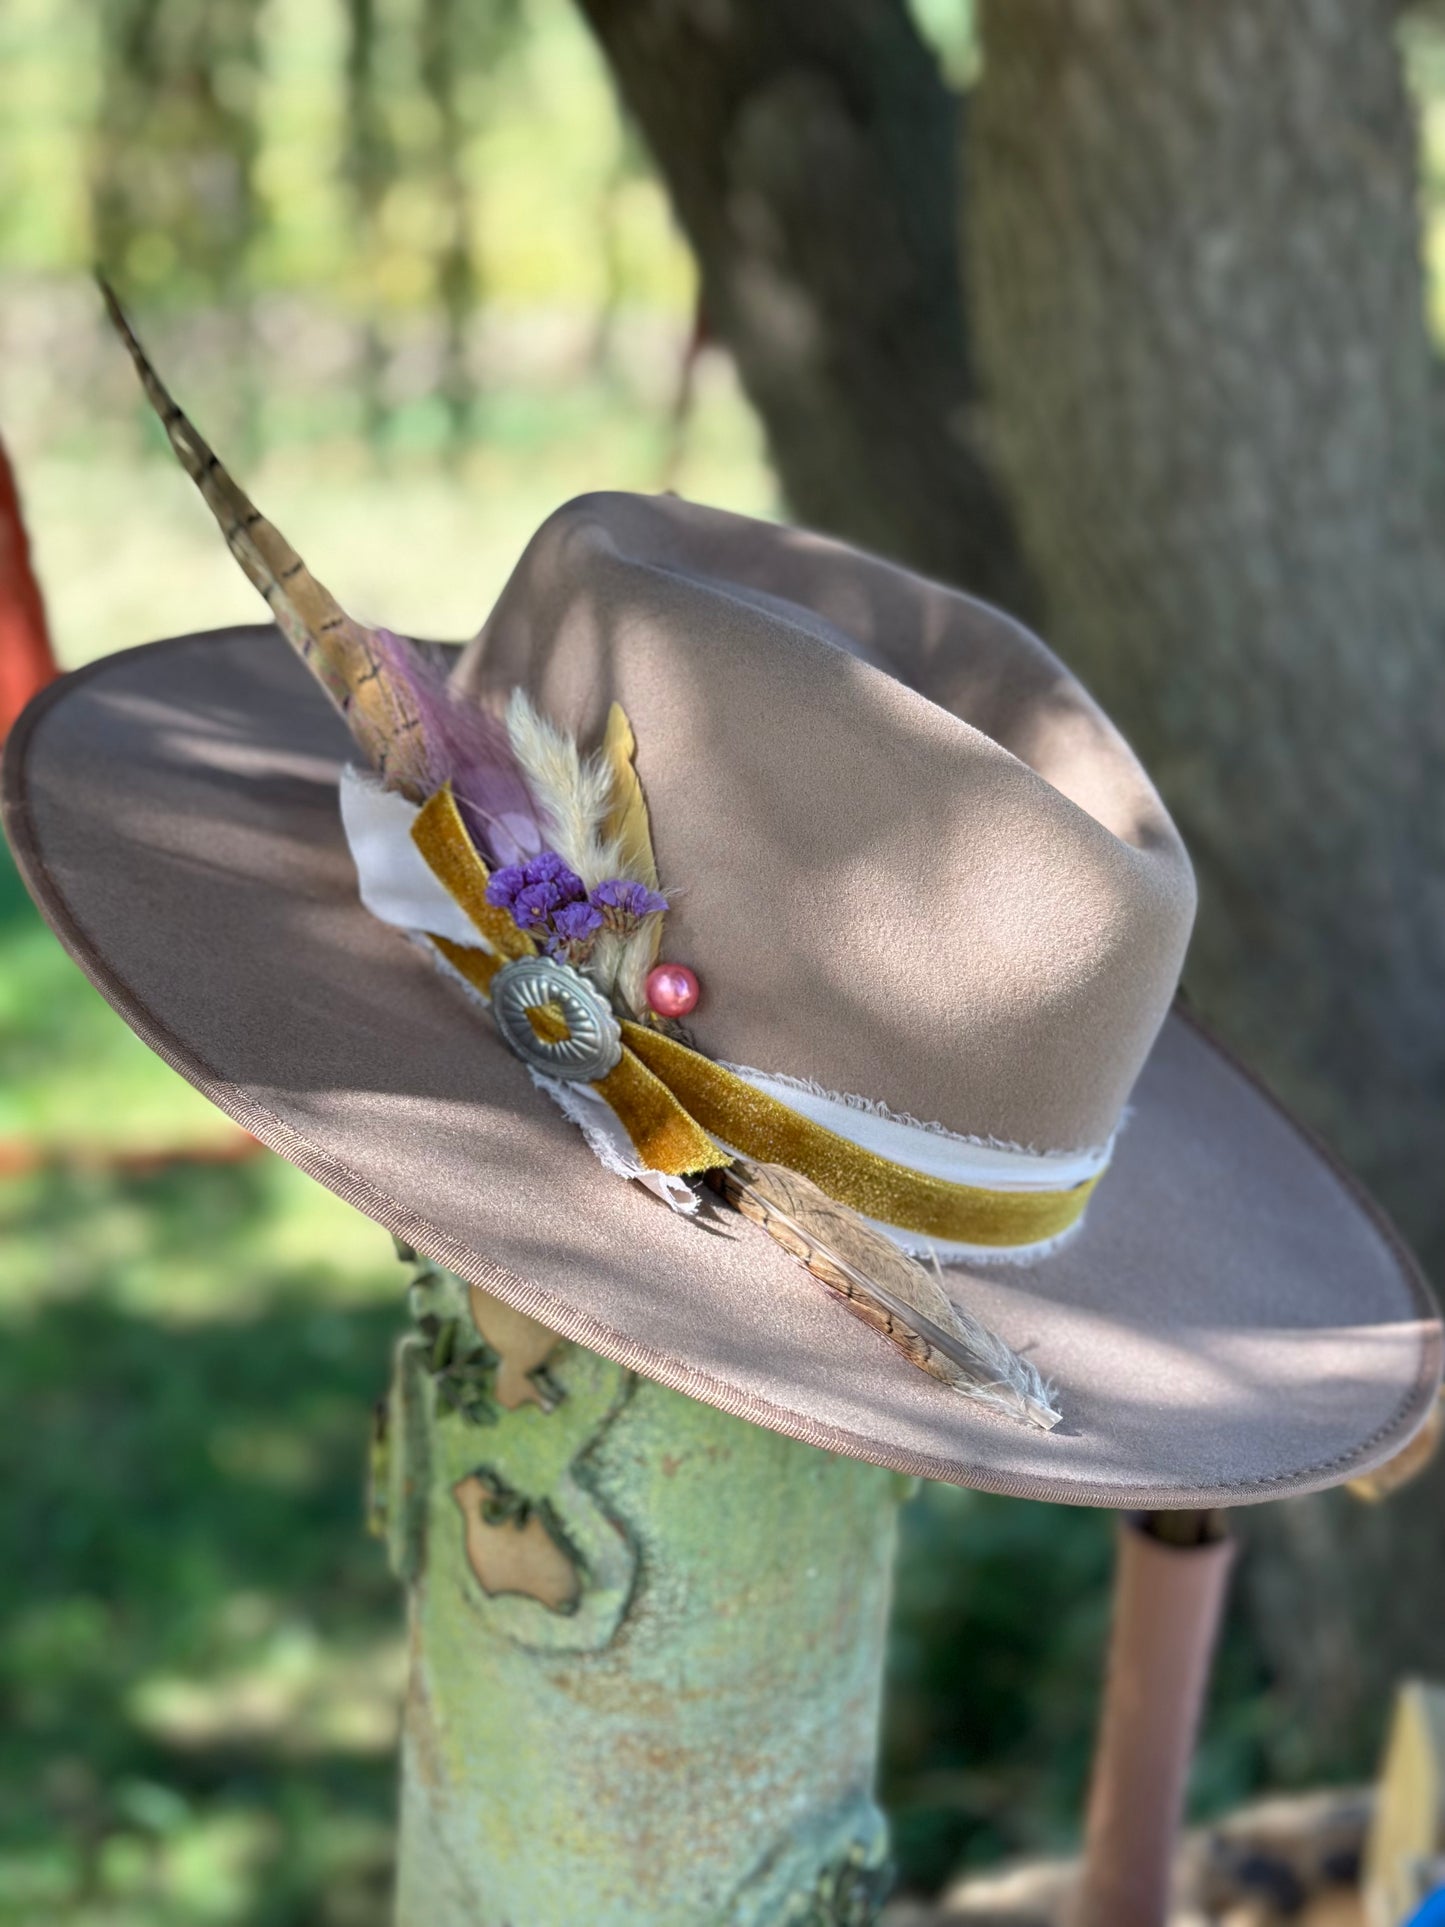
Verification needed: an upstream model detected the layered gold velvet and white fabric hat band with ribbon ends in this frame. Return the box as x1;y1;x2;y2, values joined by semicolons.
341;773;1108;1262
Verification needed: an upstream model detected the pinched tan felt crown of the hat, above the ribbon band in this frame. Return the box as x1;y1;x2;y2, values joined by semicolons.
457;495;1195;1150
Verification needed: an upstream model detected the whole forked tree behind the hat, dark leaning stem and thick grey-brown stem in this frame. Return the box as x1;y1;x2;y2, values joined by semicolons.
580;0;1445;1795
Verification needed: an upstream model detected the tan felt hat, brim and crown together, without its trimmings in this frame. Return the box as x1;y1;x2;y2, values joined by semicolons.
4;495;1441;1507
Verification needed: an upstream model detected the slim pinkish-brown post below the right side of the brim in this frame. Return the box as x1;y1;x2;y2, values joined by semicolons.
1069;1511;1235;1927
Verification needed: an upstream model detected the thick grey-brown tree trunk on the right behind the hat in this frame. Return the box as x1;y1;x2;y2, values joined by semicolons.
967;0;1445;1765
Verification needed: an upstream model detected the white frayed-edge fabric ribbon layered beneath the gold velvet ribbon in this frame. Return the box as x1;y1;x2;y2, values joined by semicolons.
341;769;1114;1264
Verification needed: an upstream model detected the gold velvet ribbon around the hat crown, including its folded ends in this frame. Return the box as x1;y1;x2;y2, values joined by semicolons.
412;788;1098;1249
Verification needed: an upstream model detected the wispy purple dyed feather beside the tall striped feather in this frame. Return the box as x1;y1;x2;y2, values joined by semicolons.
374;628;541;863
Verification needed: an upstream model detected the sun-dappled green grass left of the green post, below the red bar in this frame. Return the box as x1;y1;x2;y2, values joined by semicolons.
0;1133;401;1927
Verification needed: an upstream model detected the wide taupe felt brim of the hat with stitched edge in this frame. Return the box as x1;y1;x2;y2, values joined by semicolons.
4;628;1441;1507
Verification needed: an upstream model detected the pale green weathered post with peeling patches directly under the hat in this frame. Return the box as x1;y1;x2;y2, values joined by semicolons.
372;1253;909;1927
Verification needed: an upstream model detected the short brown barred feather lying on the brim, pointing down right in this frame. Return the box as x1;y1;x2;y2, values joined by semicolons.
707;1158;1060;1432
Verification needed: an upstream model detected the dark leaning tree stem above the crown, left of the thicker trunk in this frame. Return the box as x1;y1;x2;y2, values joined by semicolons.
580;0;1031;613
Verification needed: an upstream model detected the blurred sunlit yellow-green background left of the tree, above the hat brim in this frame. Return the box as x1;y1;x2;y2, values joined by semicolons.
0;0;776;665
